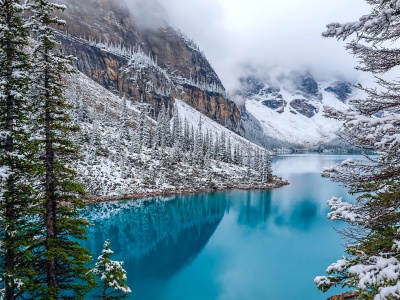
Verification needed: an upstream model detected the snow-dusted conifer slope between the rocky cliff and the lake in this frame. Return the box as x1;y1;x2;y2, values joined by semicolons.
67;74;285;200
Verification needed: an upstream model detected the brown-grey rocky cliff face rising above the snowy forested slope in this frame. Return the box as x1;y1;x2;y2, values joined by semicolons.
54;0;240;130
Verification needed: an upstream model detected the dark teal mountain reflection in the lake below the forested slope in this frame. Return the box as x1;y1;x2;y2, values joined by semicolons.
84;194;227;285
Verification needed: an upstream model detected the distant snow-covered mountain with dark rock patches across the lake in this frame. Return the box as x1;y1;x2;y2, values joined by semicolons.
235;71;357;147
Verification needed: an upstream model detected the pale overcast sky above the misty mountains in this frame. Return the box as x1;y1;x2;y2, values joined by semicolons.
128;0;370;89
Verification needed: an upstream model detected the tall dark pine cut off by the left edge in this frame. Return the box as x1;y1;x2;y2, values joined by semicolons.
0;0;41;299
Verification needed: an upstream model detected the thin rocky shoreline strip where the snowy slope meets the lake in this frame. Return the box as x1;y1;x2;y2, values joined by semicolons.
85;176;290;204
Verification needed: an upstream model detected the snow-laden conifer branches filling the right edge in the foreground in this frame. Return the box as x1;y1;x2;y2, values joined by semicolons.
315;0;400;300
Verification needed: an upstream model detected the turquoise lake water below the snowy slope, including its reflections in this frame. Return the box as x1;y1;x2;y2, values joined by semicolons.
85;154;356;300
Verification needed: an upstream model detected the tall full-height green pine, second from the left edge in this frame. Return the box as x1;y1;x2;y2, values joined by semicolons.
30;0;92;299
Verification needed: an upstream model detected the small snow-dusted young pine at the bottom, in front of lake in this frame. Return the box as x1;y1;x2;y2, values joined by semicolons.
91;240;132;300
